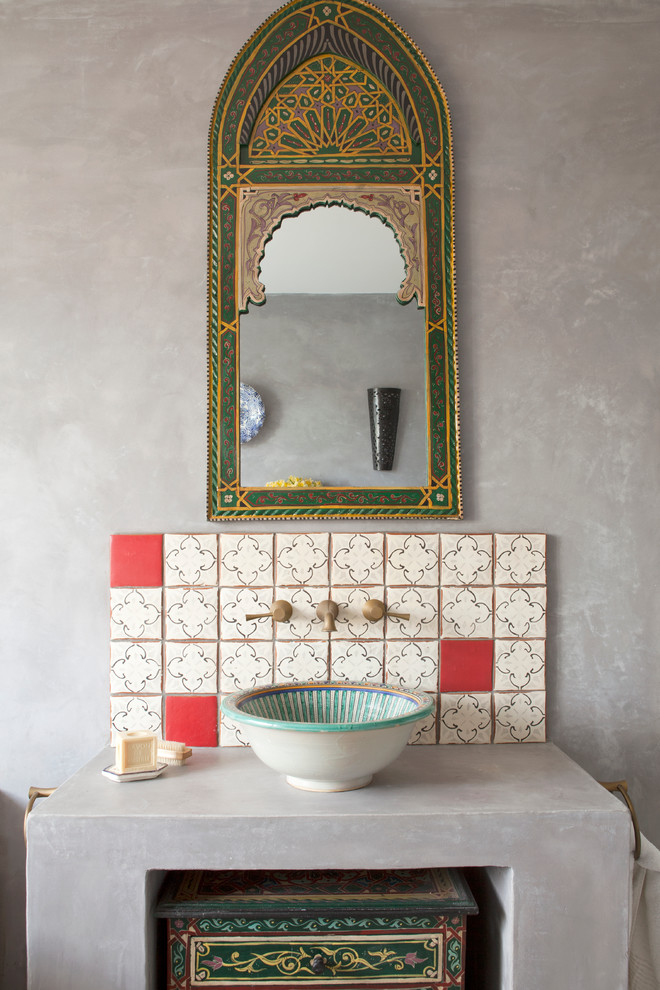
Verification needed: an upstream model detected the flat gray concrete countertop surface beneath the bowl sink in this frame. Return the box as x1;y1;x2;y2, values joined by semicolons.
37;743;628;826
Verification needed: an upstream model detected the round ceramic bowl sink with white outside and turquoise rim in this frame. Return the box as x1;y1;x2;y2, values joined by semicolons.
222;681;433;791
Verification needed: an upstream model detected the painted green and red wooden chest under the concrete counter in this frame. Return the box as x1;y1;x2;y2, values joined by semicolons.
156;869;477;990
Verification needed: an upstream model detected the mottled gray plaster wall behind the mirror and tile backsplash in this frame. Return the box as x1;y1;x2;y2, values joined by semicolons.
0;0;660;990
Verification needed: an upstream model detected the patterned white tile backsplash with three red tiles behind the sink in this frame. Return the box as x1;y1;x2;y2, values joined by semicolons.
110;533;546;746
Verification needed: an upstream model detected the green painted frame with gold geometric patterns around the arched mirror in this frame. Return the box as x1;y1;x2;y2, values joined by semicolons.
208;0;461;521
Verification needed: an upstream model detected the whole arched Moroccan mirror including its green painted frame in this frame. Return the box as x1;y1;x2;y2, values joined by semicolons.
209;0;461;520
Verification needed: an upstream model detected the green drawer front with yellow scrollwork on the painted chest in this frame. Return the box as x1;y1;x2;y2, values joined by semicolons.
190;935;443;986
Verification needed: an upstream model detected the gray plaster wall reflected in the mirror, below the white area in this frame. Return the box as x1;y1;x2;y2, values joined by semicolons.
240;292;428;488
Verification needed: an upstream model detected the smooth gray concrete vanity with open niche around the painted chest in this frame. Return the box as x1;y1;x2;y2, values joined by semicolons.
28;743;632;990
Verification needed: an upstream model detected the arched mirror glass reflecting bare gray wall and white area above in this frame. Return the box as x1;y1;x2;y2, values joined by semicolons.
240;206;428;487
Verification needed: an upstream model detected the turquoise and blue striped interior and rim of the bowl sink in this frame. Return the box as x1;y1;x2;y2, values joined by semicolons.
222;682;433;731
